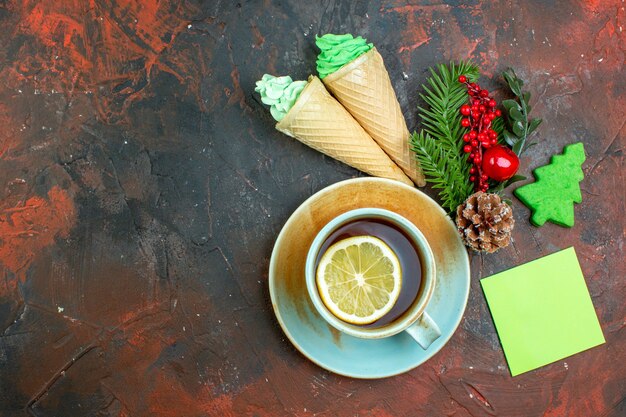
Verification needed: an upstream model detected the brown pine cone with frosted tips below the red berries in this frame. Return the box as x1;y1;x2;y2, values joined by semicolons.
456;191;515;253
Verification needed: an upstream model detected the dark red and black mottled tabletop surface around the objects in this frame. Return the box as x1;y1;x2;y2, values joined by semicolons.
0;0;626;417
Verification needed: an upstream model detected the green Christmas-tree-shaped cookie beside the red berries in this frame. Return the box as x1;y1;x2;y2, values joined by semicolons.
514;142;585;227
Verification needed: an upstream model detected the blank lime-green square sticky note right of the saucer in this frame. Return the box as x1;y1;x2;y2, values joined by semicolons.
481;248;605;376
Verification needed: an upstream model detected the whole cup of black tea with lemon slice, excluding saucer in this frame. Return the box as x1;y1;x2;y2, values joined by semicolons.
305;208;441;349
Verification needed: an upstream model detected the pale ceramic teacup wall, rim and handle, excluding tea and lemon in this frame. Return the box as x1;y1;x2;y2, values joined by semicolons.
305;208;441;349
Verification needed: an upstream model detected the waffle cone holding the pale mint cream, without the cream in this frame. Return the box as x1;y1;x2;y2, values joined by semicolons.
276;76;413;185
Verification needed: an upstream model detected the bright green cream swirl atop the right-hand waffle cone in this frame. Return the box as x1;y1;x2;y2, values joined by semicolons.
315;33;374;78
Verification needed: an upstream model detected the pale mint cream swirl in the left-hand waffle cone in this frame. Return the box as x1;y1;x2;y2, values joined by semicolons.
254;74;307;122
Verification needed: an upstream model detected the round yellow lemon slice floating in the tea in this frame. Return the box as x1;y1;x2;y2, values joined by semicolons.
316;236;402;325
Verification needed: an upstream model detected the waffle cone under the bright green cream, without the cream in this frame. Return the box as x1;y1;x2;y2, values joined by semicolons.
323;48;425;186
